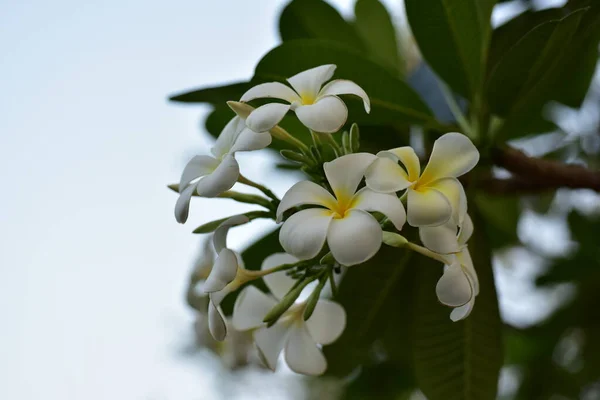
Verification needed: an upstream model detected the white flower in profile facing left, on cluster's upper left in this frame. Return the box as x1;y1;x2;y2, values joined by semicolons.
175;116;271;223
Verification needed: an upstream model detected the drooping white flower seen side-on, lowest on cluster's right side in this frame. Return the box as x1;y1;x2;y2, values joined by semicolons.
419;215;479;322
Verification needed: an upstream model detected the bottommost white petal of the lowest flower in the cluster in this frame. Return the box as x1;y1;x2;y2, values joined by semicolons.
285;323;327;375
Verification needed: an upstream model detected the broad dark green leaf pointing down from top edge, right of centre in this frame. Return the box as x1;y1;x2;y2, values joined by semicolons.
405;0;496;98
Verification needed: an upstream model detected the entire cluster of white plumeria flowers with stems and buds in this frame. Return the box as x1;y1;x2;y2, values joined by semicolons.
173;65;479;375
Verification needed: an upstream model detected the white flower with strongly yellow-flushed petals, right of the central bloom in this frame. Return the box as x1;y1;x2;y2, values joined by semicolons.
366;132;479;226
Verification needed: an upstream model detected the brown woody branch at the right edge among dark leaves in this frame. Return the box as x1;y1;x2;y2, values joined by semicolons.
492;147;600;192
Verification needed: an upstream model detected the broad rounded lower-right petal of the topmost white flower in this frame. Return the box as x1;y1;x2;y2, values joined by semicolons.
294;96;348;133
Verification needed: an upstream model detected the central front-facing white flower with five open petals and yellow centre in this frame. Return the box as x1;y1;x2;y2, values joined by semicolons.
277;153;406;266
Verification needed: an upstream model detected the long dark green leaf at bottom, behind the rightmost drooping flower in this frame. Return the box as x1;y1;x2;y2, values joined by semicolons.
413;209;503;400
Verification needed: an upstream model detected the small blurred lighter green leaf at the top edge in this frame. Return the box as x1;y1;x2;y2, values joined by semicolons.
354;0;404;76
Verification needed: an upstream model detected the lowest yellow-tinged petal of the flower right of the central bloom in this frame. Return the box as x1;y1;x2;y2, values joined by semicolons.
406;188;452;226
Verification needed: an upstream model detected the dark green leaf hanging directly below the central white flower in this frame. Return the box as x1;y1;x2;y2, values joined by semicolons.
323;246;412;376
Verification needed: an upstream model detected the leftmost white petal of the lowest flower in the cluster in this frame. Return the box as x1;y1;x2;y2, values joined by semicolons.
233;286;277;331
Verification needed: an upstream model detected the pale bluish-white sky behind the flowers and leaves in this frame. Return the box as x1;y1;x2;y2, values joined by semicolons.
0;0;580;400
